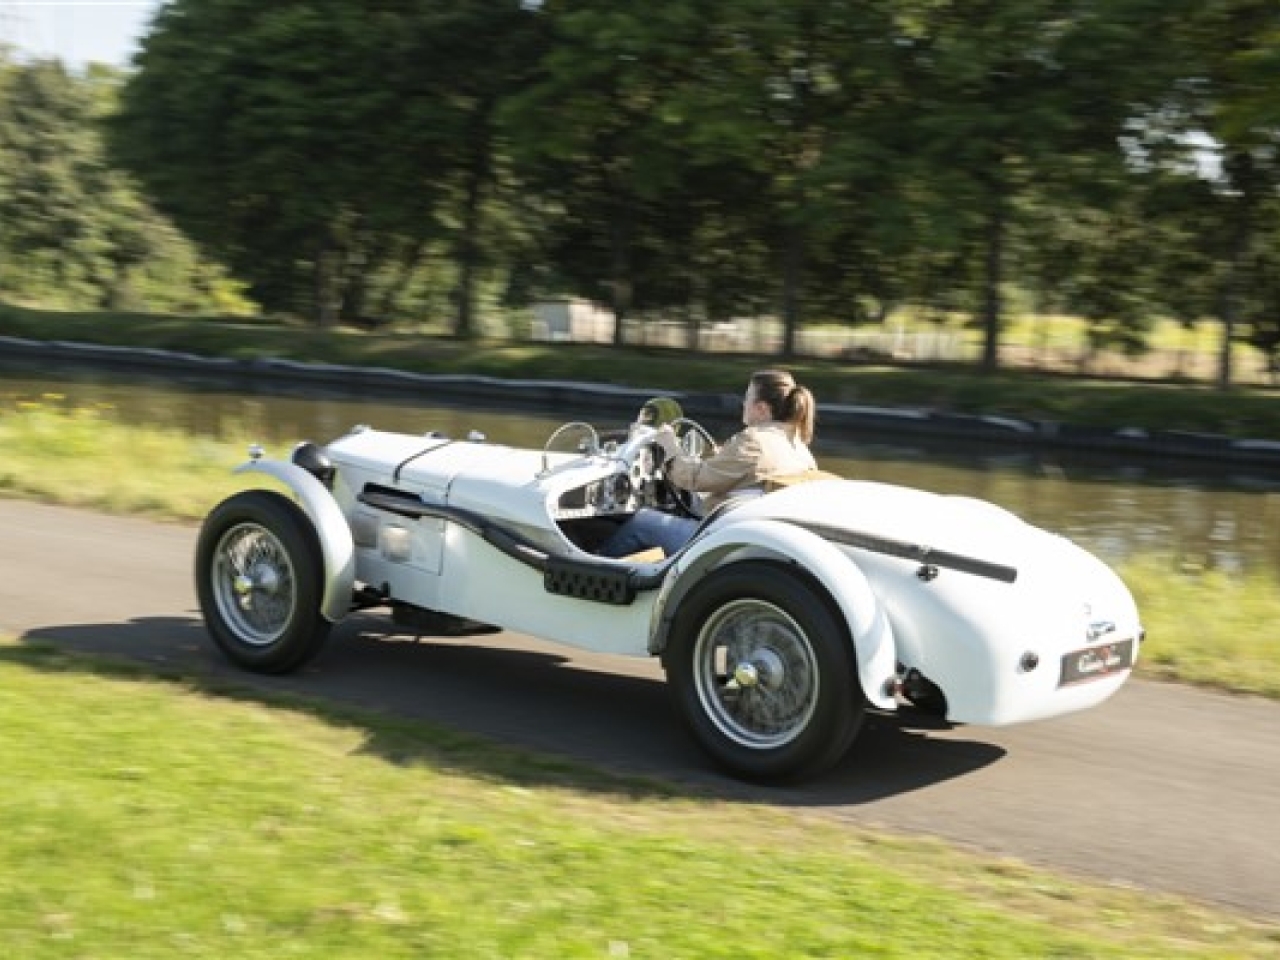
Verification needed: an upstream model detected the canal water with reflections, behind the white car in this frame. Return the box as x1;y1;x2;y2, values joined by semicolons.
0;366;1280;581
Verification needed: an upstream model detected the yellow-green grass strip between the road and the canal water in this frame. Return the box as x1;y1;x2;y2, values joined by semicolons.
0;399;1280;699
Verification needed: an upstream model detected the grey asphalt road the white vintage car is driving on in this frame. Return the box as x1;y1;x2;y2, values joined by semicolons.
0;499;1280;919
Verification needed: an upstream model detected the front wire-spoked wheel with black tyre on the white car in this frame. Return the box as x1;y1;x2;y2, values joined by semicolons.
196;490;330;673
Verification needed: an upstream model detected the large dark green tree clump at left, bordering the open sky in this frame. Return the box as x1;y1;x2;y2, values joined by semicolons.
114;0;542;326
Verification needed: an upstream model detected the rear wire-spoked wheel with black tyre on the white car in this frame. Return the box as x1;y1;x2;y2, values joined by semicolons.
663;561;867;783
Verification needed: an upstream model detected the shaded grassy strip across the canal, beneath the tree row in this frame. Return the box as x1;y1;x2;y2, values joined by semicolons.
0;305;1280;439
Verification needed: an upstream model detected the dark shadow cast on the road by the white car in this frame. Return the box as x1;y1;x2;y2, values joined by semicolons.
15;616;1004;806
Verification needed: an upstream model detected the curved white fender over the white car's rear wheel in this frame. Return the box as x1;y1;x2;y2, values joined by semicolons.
650;518;897;709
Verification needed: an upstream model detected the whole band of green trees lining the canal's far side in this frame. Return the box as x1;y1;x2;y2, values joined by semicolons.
0;0;1280;373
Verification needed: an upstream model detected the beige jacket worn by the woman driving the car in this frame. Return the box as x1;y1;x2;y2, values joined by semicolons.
667;424;818;511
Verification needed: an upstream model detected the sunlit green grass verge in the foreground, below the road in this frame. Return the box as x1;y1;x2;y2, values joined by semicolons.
0;644;1280;960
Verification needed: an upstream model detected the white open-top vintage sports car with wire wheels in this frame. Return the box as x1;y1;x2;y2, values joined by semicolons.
196;401;1143;781
